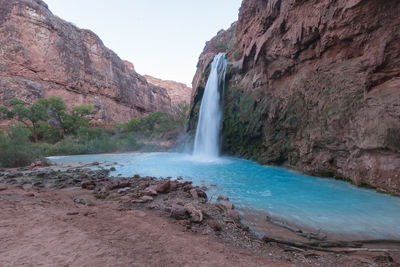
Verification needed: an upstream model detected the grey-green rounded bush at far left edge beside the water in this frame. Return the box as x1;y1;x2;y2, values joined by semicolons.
0;125;42;168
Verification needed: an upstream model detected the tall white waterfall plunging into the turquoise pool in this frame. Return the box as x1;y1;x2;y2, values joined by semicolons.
193;53;227;159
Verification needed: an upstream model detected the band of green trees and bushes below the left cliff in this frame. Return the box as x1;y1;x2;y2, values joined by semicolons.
0;96;189;167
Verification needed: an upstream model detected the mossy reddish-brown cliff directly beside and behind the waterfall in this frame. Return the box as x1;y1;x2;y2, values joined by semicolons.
190;0;400;194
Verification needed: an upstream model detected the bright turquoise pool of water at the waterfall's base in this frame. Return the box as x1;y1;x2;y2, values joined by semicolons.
50;153;400;239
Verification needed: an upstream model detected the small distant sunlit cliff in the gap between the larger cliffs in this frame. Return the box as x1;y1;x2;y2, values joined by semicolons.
144;75;192;106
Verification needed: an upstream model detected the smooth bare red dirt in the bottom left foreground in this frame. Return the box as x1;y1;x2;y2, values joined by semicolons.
0;187;286;266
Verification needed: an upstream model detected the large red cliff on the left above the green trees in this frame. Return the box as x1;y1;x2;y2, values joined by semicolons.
0;0;171;122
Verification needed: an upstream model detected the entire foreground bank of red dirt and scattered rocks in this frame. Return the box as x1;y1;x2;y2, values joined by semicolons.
0;168;400;267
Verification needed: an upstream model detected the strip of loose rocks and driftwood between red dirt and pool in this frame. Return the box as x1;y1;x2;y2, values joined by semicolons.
0;163;400;266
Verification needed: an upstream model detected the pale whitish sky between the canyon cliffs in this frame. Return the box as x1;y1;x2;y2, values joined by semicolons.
45;0;241;86
